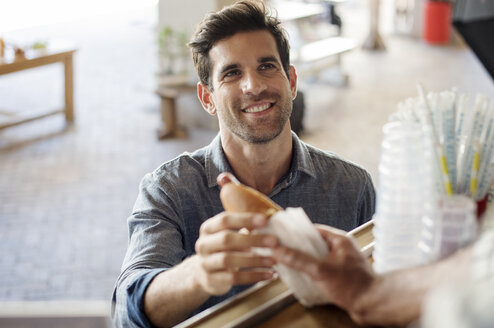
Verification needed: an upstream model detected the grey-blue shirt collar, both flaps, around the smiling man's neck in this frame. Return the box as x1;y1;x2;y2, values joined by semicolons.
205;132;316;188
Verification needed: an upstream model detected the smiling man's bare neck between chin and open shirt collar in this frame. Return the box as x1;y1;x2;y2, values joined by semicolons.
221;125;292;195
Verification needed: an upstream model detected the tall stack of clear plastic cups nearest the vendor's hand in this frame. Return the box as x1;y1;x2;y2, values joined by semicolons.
373;122;436;273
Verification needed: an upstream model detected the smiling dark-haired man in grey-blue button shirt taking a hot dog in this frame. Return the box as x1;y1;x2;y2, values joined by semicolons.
113;1;375;327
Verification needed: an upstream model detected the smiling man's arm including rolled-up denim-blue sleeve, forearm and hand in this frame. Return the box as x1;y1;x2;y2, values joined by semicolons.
112;173;276;327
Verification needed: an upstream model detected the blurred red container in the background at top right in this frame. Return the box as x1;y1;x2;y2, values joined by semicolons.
423;1;451;44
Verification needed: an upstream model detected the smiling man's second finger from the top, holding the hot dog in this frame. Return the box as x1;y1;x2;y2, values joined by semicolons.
196;230;278;255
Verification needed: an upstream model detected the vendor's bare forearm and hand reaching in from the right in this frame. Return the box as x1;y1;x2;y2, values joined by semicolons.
273;227;472;325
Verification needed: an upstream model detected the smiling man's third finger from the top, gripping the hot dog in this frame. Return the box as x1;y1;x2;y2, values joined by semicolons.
202;252;275;271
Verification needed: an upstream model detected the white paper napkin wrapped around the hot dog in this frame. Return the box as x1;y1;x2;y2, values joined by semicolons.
256;208;329;307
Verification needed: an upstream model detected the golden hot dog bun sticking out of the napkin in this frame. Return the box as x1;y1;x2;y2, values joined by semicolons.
220;182;283;217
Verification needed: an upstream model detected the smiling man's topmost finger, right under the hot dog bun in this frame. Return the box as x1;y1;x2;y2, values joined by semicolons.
201;212;268;234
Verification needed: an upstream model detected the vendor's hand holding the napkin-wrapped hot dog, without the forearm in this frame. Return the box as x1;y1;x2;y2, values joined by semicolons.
273;225;374;310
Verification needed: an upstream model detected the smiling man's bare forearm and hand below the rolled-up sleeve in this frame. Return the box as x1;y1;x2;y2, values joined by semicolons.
144;212;277;327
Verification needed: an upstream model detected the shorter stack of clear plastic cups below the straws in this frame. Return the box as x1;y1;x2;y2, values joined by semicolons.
419;195;477;263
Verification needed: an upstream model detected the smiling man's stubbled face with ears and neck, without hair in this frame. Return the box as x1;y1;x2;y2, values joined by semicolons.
198;30;297;194
